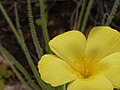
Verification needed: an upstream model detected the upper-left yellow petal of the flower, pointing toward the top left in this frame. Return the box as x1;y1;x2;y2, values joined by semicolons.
49;30;86;69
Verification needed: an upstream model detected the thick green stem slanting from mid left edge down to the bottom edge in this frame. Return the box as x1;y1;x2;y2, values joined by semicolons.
0;44;40;90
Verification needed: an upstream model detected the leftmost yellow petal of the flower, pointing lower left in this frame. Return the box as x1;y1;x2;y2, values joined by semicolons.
38;54;76;86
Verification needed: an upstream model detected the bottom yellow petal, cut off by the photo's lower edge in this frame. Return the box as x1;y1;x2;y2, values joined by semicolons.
67;76;113;90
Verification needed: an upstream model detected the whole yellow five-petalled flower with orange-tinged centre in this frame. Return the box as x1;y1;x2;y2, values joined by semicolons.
38;26;120;90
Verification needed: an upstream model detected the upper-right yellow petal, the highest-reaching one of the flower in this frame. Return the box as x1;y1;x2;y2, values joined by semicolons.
86;26;120;60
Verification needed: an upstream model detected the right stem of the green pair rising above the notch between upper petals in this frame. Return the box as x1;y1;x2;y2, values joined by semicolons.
80;0;93;32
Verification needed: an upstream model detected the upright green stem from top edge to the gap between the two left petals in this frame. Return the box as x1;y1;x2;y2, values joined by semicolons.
39;0;51;53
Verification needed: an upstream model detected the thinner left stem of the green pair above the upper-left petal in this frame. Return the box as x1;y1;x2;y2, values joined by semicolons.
76;0;86;30
